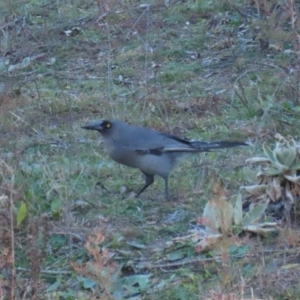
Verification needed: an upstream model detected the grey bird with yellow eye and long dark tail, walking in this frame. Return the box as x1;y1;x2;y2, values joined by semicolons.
82;119;248;199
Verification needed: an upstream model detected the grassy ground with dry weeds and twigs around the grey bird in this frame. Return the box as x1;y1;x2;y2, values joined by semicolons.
0;0;300;300
